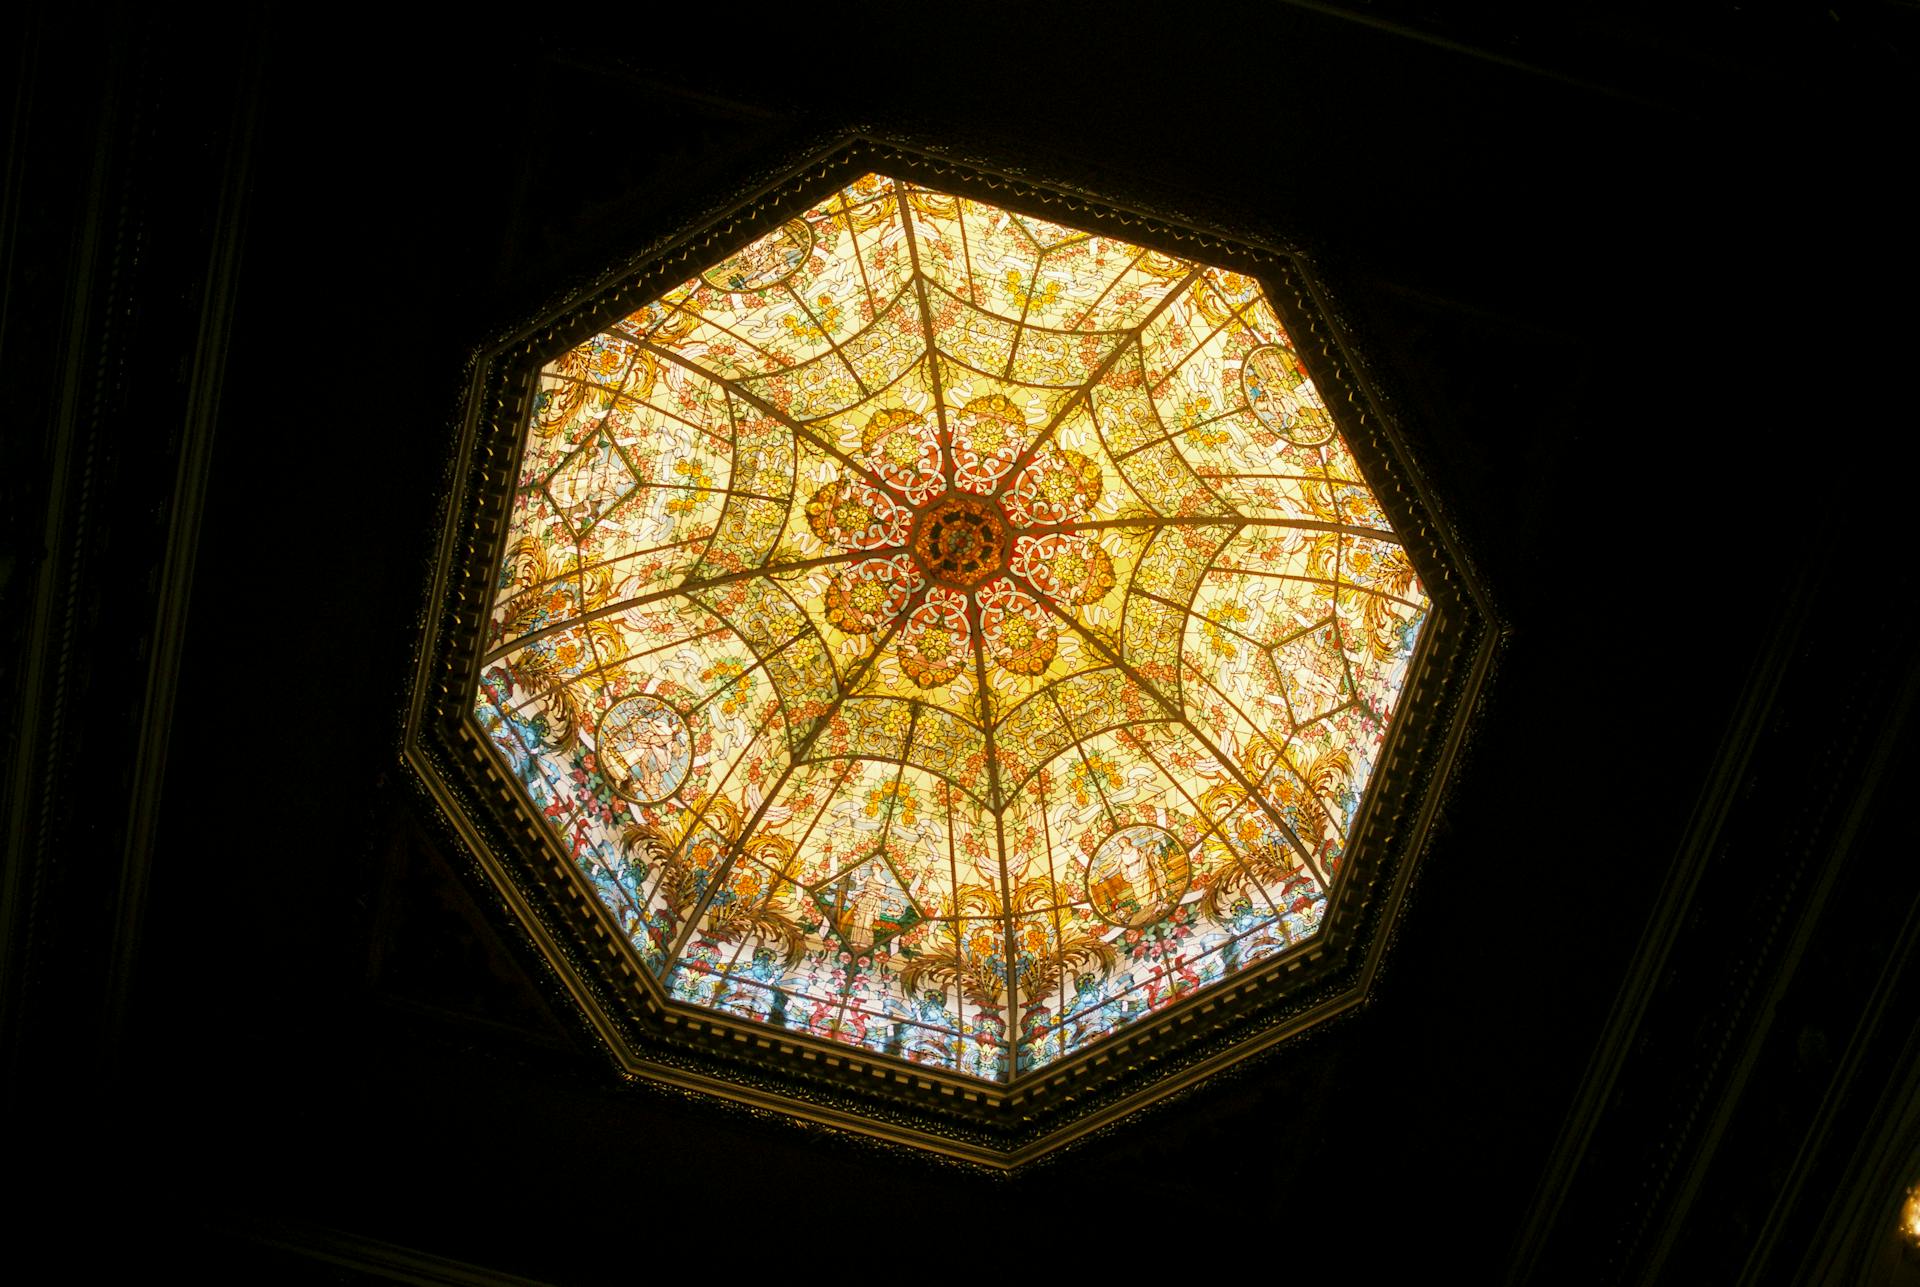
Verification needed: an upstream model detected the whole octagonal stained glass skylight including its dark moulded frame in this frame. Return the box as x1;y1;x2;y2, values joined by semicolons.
409;142;1492;1164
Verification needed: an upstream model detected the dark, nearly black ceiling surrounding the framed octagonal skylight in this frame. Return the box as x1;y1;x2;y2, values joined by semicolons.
0;2;1920;1283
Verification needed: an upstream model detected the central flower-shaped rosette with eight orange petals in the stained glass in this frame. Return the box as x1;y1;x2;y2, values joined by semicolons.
806;405;1114;688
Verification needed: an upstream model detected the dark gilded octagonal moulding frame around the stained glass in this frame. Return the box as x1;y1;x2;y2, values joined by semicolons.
403;138;1501;1170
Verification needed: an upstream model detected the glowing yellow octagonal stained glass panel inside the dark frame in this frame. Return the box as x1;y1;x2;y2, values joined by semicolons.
472;175;1430;1085
